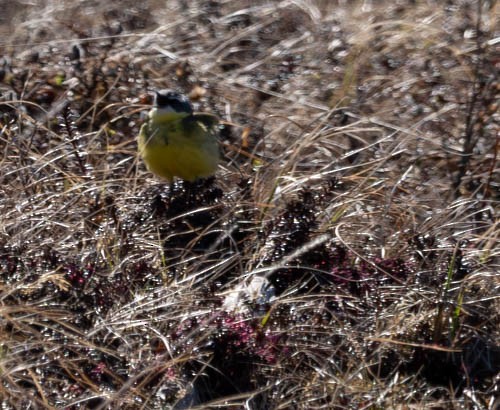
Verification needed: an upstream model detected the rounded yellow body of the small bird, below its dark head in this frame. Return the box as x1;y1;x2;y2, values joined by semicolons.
138;109;219;182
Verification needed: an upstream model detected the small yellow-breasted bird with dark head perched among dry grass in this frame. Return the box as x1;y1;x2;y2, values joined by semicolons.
138;89;220;184
